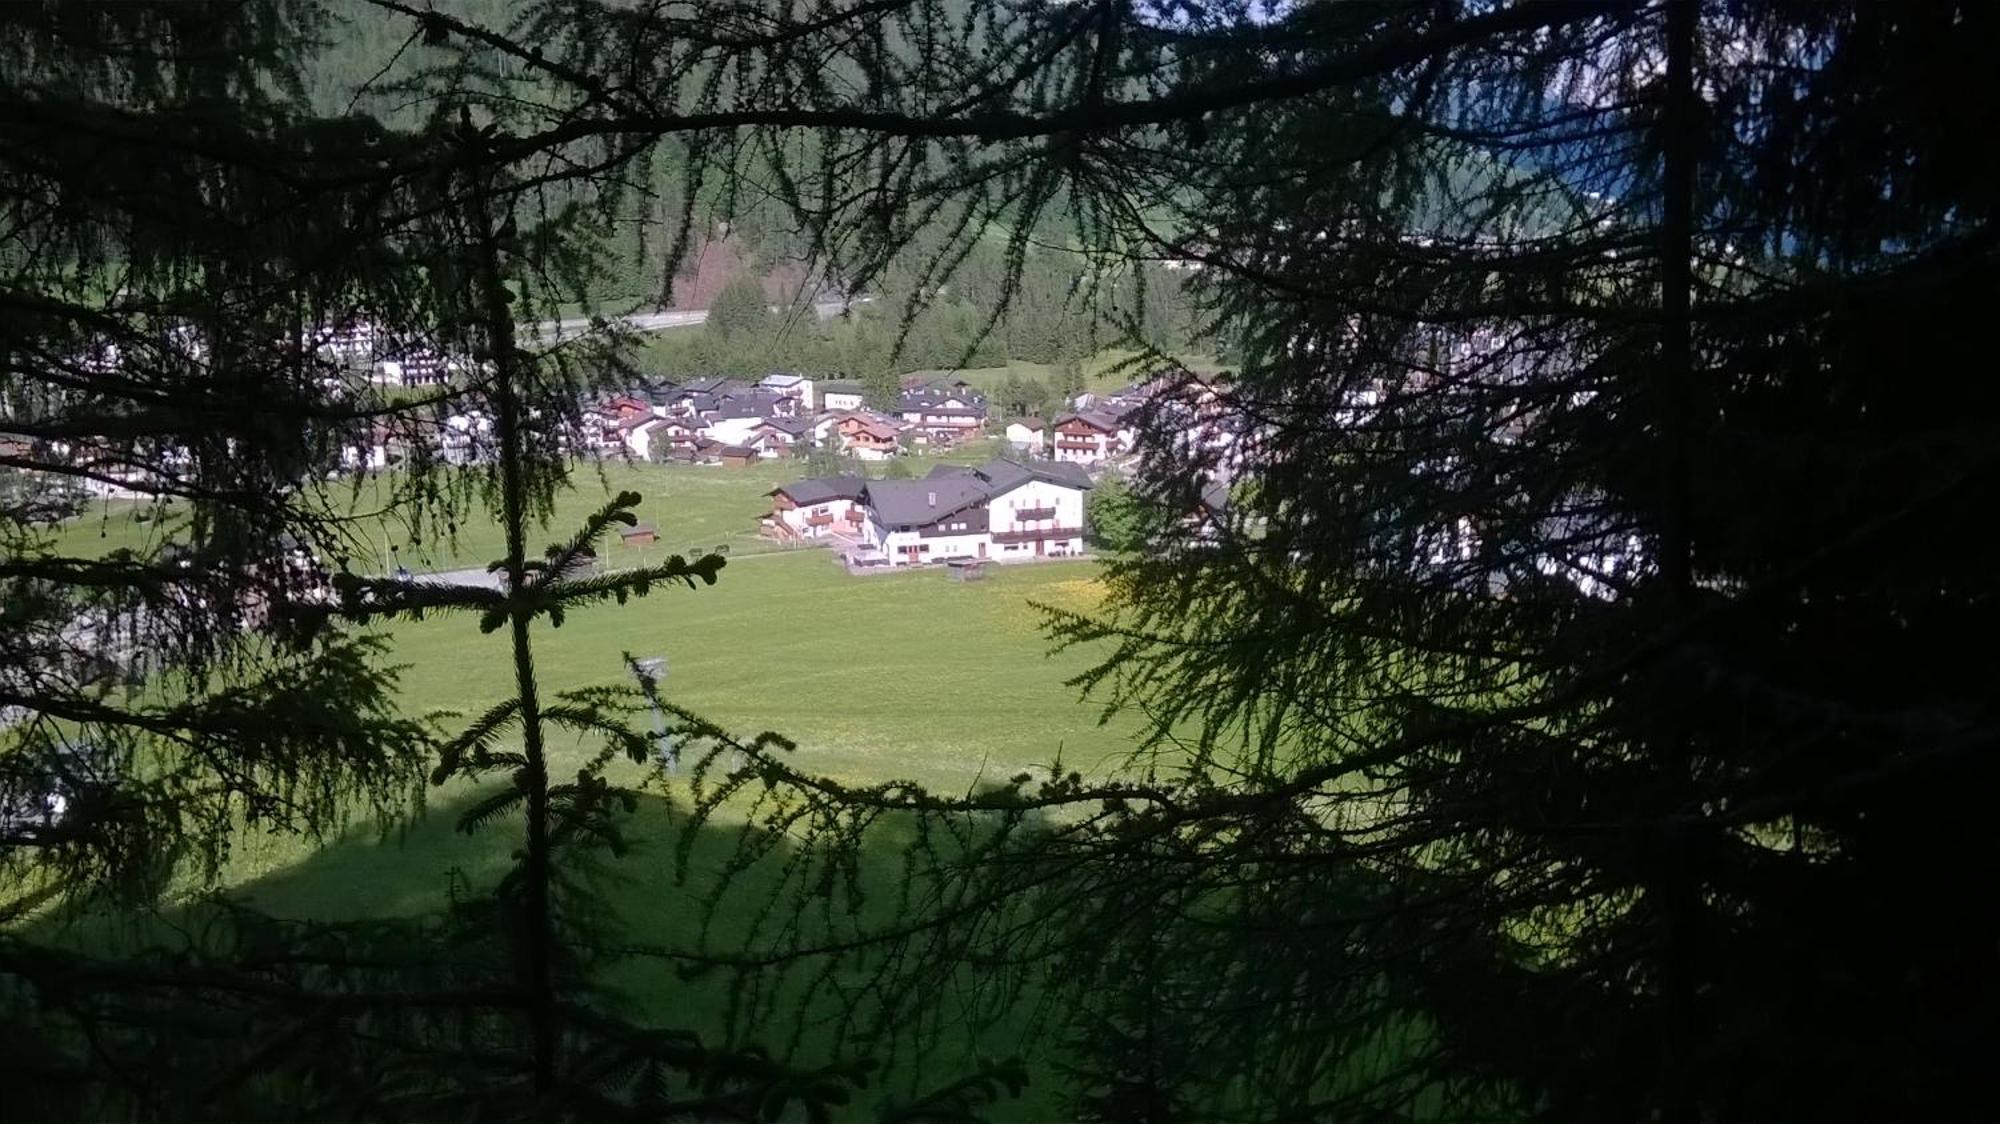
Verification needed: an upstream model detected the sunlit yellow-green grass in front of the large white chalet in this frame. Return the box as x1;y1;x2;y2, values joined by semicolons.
394;550;1120;790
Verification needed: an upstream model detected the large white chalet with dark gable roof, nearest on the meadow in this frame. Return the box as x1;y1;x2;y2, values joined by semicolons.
862;452;1090;566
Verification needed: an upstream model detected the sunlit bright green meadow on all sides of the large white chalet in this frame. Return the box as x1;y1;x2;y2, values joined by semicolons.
58;448;1130;856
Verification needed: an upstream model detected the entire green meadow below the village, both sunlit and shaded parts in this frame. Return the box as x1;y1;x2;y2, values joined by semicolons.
43;456;1132;1120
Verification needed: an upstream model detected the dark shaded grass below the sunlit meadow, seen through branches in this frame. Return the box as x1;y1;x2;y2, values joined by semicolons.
32;792;1066;1120
